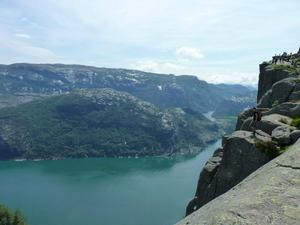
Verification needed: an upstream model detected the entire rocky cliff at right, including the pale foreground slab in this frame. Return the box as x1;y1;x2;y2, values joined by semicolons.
179;48;300;224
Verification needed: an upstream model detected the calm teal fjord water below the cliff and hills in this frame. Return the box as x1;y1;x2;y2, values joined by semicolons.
0;141;220;225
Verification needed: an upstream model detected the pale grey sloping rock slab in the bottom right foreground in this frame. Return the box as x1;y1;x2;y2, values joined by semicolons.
177;141;300;225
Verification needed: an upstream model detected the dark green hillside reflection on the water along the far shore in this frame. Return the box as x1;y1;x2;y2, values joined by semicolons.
0;155;196;176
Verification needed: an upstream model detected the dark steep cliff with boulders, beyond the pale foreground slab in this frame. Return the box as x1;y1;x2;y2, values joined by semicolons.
186;48;300;221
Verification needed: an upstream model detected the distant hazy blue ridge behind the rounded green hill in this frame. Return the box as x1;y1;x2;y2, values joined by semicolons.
0;63;251;113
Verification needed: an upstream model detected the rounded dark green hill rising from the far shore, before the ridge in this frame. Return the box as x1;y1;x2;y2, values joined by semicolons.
0;88;220;159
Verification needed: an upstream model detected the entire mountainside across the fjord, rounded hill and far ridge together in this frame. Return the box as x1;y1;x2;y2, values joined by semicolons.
0;64;255;159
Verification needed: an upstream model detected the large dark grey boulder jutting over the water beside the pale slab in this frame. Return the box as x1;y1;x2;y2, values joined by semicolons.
186;130;271;215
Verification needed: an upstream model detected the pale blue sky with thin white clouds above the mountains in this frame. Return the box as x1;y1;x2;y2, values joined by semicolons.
0;0;300;86
